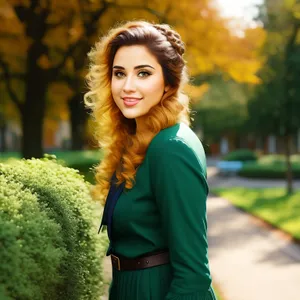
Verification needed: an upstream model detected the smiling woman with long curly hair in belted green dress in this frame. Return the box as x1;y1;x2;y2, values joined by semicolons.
85;21;216;300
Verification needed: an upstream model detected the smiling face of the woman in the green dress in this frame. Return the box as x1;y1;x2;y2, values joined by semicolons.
111;45;168;119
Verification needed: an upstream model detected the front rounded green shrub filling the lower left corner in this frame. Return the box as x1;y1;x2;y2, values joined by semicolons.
0;175;67;300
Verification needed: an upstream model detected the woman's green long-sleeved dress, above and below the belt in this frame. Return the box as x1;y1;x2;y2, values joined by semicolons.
102;123;216;300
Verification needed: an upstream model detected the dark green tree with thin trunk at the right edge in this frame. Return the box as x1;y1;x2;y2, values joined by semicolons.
249;0;300;194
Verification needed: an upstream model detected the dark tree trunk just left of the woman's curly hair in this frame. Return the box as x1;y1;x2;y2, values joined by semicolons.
69;93;88;150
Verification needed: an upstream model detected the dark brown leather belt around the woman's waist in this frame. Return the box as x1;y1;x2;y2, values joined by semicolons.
110;250;170;271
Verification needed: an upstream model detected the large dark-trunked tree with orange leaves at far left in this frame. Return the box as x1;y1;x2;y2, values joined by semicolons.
0;1;84;158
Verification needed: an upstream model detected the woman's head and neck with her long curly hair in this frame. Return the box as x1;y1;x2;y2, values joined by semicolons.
85;22;190;193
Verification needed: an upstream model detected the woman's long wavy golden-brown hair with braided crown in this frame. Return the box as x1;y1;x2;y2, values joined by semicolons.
84;21;190;203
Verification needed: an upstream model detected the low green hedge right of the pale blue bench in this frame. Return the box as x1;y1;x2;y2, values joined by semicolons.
238;162;300;179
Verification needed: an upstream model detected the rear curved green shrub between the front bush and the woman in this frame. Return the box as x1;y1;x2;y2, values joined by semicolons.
0;159;104;300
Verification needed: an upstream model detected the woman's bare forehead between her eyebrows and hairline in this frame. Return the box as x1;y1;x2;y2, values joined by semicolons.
113;45;158;67
